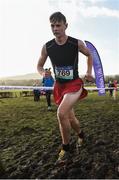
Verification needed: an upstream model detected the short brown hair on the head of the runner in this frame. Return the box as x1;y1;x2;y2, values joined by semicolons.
49;12;66;23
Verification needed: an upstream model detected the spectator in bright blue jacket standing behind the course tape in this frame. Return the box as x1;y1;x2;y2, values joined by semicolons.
42;68;54;111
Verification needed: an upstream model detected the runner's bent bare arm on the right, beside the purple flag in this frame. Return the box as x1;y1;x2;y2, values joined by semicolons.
78;40;93;81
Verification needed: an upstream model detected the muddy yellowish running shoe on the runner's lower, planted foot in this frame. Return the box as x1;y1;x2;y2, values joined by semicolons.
56;149;70;165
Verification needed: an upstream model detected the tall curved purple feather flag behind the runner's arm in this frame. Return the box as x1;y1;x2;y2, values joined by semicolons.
85;41;105;96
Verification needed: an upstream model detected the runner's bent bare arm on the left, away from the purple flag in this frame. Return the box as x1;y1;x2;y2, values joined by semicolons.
37;45;48;75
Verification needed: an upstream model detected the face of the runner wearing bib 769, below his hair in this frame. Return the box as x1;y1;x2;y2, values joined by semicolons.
51;21;67;38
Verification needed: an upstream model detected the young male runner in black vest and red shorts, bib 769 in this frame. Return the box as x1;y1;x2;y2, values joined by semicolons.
37;12;93;163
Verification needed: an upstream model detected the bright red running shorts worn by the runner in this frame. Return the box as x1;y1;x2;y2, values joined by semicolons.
53;78;88;105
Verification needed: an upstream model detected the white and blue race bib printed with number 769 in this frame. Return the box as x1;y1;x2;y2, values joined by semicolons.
55;66;73;80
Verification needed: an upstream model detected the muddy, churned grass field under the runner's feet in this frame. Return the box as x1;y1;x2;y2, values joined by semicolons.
0;93;119;179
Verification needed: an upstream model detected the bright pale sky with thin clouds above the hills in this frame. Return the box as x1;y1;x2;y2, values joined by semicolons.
0;0;119;77
